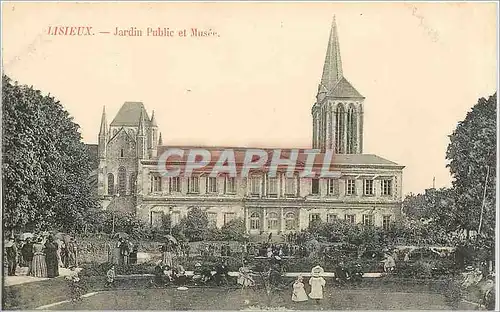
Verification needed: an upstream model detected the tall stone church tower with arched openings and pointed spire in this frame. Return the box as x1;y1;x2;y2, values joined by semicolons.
312;16;365;154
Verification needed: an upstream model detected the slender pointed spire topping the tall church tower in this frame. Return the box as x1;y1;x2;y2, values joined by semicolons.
319;15;343;92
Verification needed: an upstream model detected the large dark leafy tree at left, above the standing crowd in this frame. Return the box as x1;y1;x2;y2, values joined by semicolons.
2;75;97;232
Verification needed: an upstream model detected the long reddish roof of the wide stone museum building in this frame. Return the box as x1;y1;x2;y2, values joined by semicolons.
152;145;404;169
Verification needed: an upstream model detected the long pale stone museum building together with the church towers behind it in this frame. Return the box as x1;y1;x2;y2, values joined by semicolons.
97;20;404;234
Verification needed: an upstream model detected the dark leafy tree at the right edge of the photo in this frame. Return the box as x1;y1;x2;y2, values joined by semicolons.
446;93;497;239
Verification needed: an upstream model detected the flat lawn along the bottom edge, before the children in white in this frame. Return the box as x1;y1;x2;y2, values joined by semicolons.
52;288;464;310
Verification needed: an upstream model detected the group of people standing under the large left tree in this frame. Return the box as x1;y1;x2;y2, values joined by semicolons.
4;233;78;278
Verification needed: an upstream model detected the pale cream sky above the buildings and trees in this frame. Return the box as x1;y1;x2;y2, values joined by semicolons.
2;3;497;194
